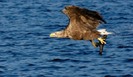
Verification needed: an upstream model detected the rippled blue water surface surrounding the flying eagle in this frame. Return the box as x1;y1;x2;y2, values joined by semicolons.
0;0;133;77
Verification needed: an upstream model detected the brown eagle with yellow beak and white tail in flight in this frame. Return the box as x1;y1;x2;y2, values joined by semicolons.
50;5;111;53
